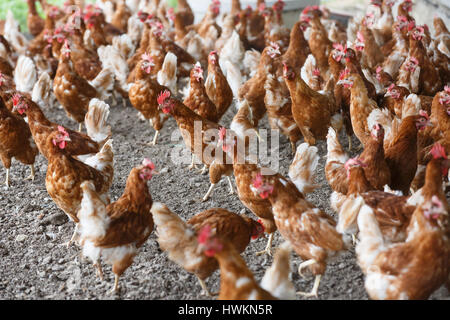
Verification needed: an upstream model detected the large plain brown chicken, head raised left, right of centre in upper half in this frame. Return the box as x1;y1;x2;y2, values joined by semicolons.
283;63;340;145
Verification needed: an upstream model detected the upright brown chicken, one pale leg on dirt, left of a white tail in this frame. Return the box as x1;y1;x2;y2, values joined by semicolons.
128;53;171;145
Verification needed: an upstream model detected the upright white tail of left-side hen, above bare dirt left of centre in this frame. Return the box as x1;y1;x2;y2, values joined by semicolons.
84;98;111;143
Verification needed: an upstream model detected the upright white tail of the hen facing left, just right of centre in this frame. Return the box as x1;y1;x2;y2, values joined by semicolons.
289;142;319;193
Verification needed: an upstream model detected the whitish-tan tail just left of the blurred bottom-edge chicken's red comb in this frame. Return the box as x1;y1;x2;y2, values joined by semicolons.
150;202;203;269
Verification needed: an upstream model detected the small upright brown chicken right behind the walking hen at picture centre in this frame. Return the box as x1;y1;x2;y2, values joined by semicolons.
183;63;218;122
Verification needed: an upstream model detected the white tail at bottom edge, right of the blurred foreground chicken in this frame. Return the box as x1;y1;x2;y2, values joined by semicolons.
261;241;296;300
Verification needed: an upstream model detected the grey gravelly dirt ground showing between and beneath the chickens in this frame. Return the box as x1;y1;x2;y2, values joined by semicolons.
0;95;450;300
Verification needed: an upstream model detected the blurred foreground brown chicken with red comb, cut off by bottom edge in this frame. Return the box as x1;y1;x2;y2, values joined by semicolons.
197;222;275;300
